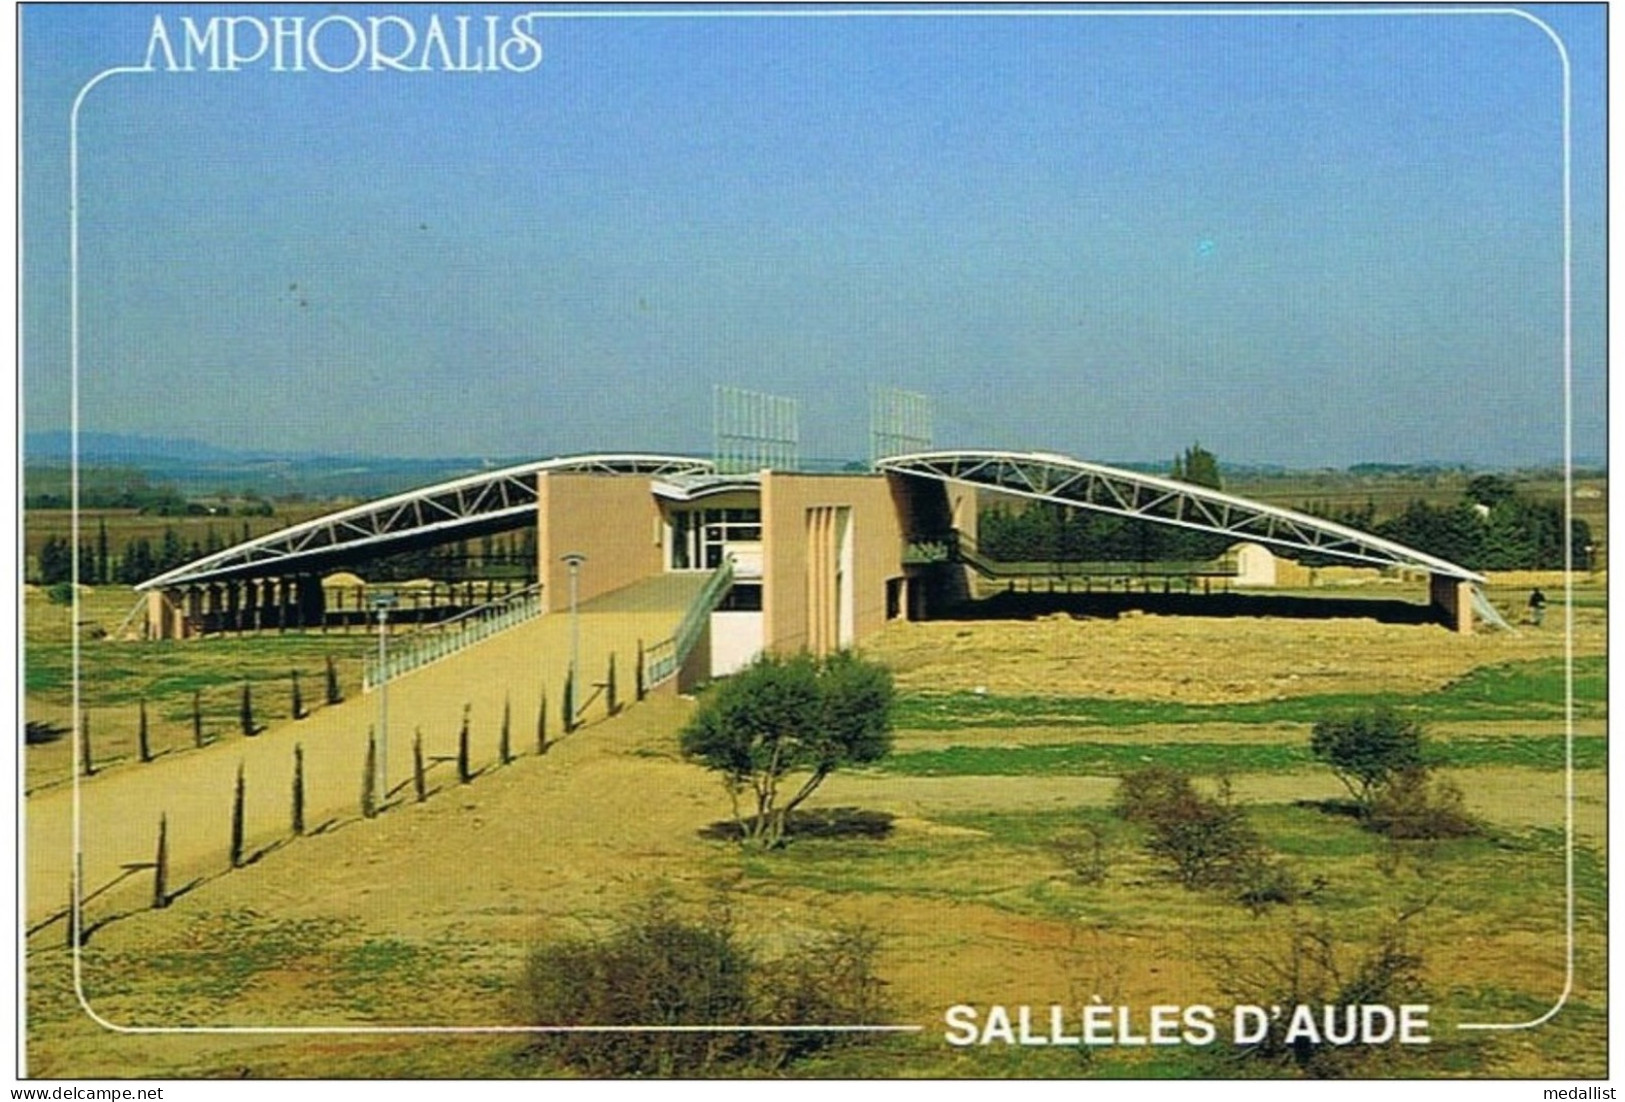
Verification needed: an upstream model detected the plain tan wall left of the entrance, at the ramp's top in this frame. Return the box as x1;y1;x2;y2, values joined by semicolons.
536;471;661;611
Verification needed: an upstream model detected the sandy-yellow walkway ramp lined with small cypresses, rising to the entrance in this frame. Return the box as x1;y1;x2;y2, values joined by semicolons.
24;575;705;936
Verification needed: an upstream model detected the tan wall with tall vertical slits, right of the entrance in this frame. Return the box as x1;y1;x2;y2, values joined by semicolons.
762;471;904;653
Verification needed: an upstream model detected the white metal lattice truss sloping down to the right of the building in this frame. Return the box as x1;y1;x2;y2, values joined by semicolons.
876;452;1484;584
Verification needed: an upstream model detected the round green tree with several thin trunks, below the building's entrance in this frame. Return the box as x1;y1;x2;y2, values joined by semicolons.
681;652;892;848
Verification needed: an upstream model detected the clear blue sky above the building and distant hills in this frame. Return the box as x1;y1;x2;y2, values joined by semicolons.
23;5;1606;466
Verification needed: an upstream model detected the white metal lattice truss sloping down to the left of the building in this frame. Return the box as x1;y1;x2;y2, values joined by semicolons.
137;453;713;590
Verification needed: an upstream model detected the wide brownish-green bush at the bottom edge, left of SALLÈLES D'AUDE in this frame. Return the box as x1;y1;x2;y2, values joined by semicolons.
523;897;886;1078
